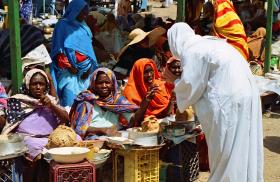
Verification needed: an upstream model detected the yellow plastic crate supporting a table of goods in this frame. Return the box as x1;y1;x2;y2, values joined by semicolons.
113;148;159;182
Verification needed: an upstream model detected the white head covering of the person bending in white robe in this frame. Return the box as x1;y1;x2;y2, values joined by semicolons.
167;23;202;59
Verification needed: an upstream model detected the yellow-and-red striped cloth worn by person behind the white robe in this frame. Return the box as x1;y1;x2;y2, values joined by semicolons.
212;0;249;60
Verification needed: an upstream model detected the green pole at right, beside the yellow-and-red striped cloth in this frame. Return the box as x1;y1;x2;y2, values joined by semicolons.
264;0;273;73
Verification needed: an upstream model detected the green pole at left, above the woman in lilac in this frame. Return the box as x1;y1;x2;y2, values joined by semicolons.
8;0;22;92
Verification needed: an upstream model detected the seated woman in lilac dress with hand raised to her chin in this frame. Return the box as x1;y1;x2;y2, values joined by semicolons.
2;68;69;181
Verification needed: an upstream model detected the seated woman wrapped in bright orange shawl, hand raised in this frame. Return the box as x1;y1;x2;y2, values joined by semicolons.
124;58;172;118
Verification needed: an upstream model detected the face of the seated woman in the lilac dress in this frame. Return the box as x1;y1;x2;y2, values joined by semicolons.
29;73;47;99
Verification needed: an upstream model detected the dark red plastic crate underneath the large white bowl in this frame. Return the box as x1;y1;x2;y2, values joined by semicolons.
49;161;96;182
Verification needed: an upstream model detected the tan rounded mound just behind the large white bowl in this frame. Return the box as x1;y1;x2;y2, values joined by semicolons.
46;125;78;148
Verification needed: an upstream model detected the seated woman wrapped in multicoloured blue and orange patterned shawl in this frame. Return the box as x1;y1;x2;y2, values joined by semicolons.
70;68;148;139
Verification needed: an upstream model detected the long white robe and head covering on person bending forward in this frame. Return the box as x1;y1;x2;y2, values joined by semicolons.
168;23;263;182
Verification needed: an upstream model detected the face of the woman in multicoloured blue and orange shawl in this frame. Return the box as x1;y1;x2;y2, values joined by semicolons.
95;73;113;98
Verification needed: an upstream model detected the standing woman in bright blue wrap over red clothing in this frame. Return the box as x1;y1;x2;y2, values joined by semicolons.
51;0;98;106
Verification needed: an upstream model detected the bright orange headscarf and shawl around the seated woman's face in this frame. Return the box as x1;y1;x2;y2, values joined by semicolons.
124;58;171;118
